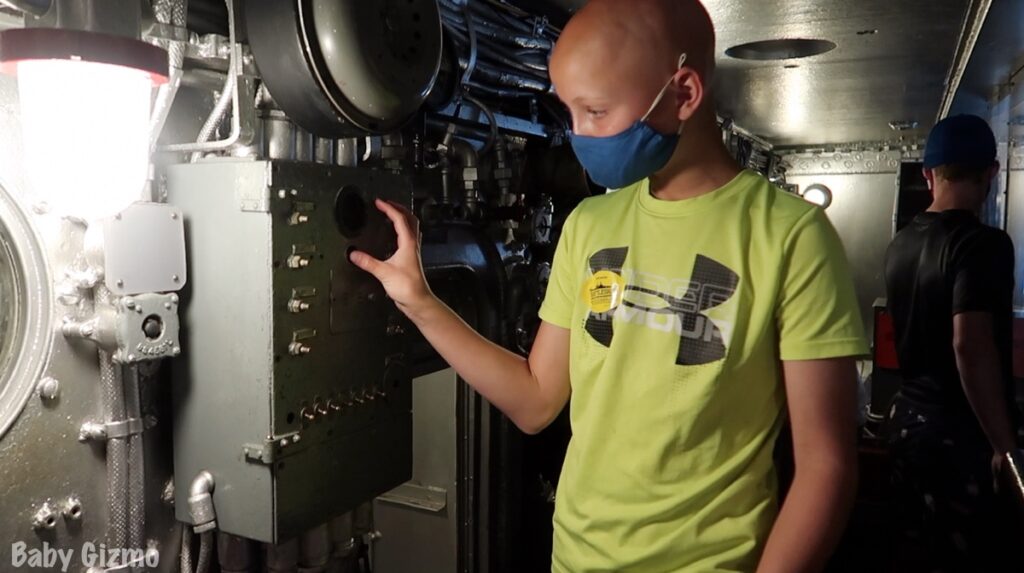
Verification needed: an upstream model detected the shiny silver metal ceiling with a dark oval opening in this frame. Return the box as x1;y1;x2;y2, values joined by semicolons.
520;0;970;146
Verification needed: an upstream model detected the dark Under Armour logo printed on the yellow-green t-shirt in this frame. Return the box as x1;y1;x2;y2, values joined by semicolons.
586;248;739;366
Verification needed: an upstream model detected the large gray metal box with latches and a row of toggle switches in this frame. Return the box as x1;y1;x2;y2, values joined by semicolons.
167;160;412;542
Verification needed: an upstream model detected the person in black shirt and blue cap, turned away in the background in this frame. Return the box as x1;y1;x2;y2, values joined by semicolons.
885;116;1024;571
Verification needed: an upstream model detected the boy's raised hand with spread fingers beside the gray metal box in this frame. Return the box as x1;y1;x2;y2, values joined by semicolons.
349;200;434;318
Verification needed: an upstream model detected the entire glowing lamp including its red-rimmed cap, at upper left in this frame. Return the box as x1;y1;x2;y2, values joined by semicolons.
0;28;167;221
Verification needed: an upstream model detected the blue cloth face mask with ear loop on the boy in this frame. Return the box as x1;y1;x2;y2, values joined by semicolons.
569;53;686;189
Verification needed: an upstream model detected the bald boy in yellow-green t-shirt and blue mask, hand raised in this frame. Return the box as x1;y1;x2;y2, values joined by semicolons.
352;0;867;573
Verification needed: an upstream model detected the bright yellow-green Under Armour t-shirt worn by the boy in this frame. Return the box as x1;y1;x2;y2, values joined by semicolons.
540;171;867;573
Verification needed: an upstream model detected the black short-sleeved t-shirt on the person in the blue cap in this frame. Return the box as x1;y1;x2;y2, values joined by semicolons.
886;211;1017;418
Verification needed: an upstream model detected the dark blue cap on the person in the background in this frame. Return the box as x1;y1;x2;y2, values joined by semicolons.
925;116;995;169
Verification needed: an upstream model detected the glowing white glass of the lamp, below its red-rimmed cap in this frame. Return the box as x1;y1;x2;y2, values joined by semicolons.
17;59;153;220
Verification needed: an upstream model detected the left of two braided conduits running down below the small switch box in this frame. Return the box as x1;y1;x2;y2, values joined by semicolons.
99;350;128;547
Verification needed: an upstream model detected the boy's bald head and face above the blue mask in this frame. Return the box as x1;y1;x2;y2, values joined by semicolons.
551;0;715;134
